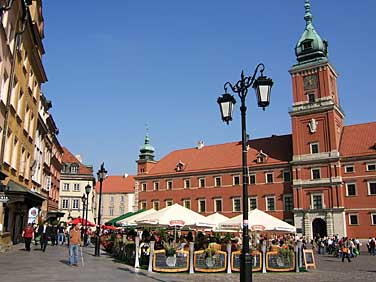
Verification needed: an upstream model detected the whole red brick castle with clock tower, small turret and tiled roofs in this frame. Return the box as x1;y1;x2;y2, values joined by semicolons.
135;0;376;238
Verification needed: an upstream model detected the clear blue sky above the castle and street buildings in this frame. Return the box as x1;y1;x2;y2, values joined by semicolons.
42;0;376;175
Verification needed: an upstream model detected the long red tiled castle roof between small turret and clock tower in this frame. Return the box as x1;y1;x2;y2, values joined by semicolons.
148;134;292;175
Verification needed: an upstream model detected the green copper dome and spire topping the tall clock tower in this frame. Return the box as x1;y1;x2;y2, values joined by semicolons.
295;0;328;63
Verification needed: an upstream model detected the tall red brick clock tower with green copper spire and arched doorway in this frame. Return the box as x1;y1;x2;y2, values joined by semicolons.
289;0;346;238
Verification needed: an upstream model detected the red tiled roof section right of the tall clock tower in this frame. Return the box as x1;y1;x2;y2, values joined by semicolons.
339;122;376;157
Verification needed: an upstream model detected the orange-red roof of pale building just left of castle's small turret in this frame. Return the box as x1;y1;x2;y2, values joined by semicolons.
95;175;134;193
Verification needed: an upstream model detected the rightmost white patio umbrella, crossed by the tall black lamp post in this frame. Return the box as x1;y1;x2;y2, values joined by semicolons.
219;209;296;233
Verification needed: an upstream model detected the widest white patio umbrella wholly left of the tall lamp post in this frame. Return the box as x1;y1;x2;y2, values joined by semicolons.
136;204;215;228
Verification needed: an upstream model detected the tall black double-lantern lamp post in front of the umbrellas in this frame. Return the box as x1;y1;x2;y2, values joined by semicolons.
217;64;273;282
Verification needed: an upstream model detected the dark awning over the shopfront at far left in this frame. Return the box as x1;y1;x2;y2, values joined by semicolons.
5;180;47;207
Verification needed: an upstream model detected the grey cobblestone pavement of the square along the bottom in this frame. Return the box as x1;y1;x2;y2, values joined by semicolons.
0;245;376;282
